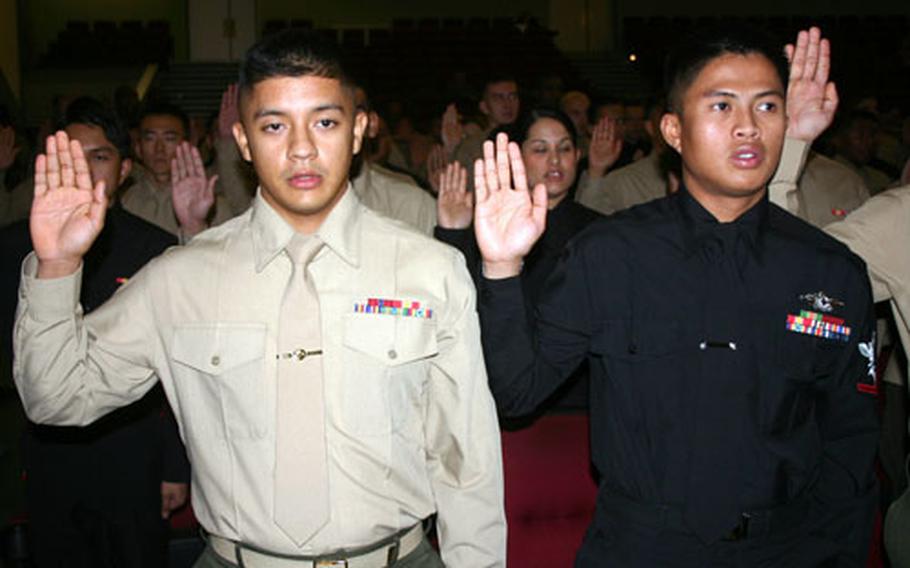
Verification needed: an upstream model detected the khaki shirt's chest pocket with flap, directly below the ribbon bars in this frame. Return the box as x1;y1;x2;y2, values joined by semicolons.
340;313;439;435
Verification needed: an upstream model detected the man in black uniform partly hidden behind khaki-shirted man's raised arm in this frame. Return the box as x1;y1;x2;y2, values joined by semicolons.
0;98;189;568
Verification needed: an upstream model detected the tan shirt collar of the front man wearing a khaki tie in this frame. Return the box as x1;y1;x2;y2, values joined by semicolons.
250;183;362;272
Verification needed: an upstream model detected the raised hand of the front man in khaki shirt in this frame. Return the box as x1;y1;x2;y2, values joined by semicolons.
29;131;107;278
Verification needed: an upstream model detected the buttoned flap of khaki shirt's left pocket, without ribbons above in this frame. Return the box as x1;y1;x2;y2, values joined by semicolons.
171;324;266;375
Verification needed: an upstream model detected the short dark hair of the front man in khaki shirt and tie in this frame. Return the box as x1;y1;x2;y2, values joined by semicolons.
238;28;355;96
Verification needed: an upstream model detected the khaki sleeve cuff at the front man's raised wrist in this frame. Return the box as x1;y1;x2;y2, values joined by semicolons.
19;252;82;322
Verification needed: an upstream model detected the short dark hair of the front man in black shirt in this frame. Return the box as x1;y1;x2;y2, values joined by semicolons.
664;24;787;113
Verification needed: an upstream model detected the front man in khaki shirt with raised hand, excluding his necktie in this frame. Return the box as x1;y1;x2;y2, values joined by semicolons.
15;30;505;568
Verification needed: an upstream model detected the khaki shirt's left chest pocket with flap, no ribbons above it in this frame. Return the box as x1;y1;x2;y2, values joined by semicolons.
171;324;269;440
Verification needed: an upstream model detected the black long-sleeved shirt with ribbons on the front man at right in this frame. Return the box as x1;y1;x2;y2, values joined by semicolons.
479;188;877;556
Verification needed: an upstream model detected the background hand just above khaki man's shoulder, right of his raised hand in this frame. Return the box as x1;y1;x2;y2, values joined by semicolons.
171;142;218;236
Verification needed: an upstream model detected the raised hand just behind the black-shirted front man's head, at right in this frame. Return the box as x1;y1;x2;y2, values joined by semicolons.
784;27;838;142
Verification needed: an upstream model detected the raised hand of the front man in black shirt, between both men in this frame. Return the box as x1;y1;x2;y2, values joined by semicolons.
474;133;547;278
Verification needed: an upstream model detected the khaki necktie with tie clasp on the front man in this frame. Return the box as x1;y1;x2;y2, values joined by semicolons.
274;235;329;546
